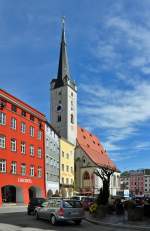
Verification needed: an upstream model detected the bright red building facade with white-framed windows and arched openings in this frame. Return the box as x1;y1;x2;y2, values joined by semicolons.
0;89;46;205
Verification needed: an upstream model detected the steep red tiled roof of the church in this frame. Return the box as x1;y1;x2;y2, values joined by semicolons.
77;127;117;170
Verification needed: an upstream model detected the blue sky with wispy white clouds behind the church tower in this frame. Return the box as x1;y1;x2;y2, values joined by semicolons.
0;0;150;170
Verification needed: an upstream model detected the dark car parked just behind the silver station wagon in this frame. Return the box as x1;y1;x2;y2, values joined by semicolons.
27;197;46;215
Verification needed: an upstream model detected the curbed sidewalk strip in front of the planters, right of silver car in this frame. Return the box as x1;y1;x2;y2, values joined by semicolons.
85;211;150;231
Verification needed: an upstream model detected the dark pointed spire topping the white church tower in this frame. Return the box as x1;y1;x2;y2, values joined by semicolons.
57;17;70;83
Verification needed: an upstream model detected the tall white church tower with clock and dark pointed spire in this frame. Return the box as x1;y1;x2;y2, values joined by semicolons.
51;19;77;144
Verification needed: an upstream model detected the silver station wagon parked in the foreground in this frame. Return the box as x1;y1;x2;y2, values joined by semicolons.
35;198;84;225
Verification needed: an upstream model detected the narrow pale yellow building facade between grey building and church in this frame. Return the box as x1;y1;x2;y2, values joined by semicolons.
60;137;75;197
